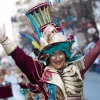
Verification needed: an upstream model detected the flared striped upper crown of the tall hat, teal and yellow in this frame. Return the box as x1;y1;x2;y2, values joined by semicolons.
26;2;61;34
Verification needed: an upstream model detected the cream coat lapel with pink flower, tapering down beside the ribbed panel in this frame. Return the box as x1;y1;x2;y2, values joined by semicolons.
42;66;67;98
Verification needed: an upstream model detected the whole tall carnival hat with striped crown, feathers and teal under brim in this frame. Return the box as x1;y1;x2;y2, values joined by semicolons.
20;2;74;60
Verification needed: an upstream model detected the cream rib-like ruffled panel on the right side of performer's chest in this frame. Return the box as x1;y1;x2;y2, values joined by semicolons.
59;64;83;96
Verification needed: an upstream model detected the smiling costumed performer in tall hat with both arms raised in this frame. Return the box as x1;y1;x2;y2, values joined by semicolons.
0;2;100;100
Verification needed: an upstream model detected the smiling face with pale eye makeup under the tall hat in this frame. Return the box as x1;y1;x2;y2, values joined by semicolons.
49;51;66;70
